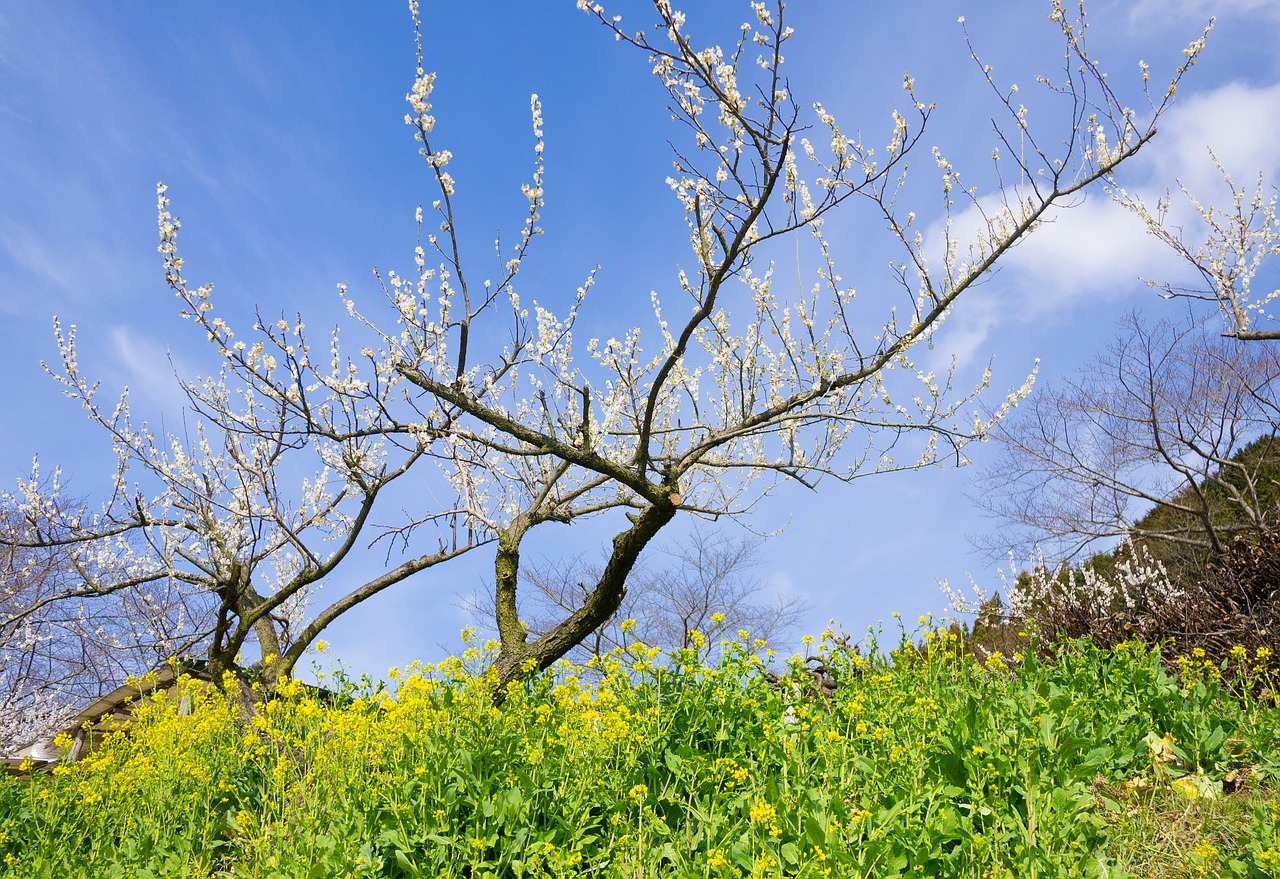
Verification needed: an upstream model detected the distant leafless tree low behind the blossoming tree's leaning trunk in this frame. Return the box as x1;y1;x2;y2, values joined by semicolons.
466;526;808;660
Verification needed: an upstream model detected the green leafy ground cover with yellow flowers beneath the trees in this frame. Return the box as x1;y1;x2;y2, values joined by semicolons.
0;621;1280;879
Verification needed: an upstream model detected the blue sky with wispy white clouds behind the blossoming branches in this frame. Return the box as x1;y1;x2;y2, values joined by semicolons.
0;0;1280;673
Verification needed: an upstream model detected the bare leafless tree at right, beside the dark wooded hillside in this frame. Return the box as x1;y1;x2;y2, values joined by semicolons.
974;313;1280;560
